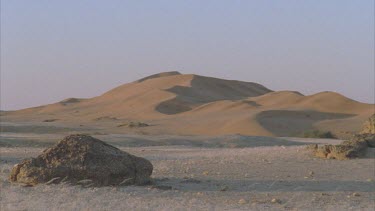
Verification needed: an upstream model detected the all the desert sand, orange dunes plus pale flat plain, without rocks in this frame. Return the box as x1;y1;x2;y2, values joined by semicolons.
0;72;375;210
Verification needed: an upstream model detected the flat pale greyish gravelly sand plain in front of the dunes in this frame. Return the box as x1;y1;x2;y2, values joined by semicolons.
0;133;375;210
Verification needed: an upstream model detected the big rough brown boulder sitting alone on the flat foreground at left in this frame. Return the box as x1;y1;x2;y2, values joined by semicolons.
10;135;153;186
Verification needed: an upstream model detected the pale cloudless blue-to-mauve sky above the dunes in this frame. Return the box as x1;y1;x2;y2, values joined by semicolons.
0;0;375;110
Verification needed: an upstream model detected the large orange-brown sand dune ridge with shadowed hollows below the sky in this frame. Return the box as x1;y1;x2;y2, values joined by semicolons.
2;72;374;136
